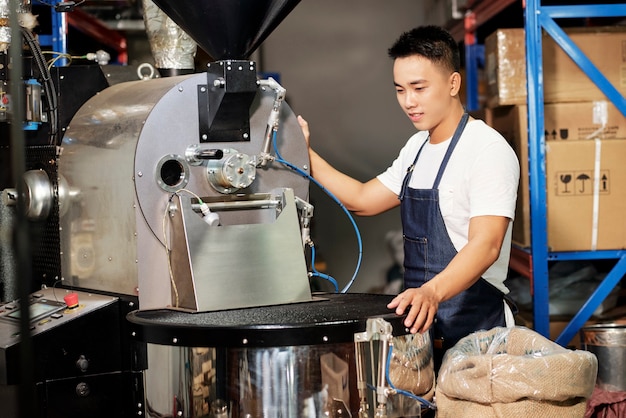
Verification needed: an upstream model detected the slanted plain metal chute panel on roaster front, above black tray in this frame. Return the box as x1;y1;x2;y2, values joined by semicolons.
171;189;311;311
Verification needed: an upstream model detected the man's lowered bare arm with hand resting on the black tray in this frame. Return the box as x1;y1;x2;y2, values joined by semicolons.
387;216;511;333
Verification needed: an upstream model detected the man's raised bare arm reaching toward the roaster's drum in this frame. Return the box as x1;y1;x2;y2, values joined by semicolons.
298;117;400;216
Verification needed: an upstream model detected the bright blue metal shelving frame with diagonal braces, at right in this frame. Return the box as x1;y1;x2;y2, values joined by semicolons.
525;0;626;345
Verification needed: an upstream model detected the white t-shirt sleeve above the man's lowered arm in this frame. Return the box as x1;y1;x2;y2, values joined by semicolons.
469;139;520;219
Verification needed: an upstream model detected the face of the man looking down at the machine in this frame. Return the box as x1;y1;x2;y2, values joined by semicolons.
393;55;456;131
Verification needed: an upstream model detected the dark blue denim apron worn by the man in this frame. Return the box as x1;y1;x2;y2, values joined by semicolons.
399;113;505;350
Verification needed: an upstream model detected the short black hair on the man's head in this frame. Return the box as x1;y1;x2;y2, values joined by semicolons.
388;26;461;72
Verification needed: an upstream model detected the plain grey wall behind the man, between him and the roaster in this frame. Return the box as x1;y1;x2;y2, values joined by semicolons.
260;0;437;292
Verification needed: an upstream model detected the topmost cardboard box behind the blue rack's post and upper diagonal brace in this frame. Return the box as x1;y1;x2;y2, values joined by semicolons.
485;26;626;107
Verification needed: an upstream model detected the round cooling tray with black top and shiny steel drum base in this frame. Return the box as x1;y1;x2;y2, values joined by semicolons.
127;293;434;418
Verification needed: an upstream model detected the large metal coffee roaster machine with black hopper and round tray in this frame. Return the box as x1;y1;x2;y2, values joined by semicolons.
0;0;434;418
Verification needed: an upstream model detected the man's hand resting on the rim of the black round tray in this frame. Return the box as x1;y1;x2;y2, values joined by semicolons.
387;286;439;334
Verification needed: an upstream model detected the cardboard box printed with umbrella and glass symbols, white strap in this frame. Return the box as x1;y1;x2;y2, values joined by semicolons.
546;139;626;251
